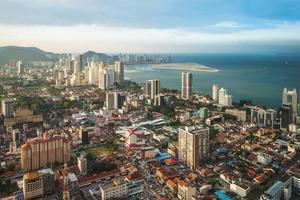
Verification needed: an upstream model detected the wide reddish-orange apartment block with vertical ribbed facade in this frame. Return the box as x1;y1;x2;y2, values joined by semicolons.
21;134;70;171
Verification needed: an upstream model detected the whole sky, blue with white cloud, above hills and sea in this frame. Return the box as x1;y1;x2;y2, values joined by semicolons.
0;0;300;53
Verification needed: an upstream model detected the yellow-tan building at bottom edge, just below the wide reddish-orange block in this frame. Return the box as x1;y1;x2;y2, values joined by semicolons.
23;172;43;199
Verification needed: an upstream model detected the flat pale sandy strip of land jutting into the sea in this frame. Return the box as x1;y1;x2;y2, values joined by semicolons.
152;63;219;72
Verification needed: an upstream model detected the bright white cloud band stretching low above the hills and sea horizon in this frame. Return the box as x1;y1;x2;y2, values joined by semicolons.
0;22;300;53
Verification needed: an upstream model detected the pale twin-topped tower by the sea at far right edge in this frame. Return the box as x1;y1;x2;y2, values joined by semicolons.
282;88;297;122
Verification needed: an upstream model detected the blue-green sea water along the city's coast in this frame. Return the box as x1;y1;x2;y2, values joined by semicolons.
125;54;300;108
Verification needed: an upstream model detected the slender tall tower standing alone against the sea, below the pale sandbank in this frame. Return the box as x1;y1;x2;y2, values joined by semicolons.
181;72;193;99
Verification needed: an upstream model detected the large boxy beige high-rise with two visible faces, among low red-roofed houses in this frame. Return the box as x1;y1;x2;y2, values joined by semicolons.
178;127;209;168
